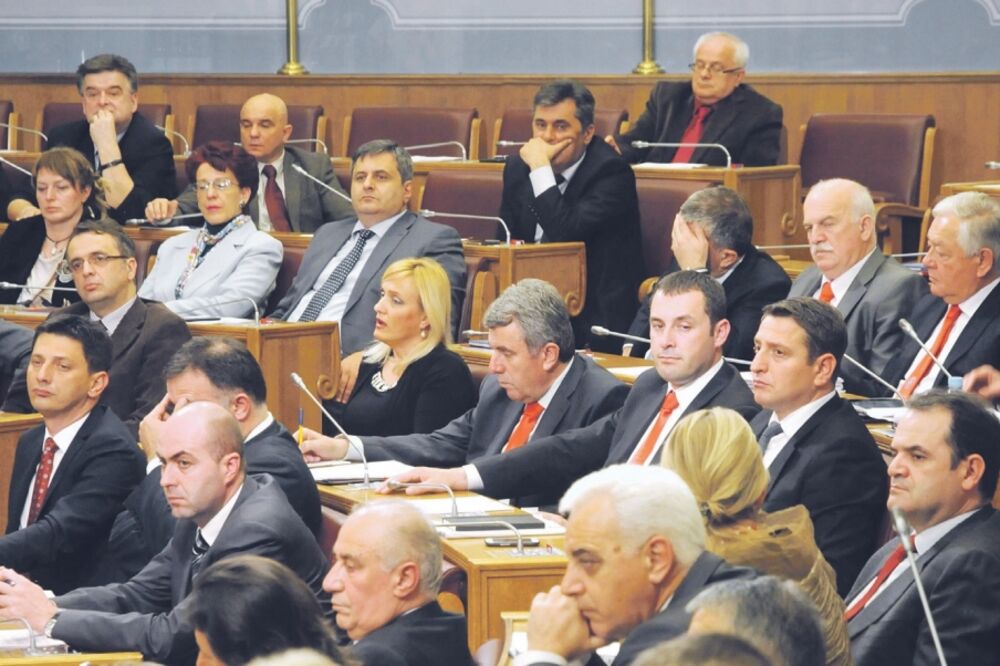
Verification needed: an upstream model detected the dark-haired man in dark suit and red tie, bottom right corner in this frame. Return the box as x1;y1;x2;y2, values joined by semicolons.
845;390;1000;666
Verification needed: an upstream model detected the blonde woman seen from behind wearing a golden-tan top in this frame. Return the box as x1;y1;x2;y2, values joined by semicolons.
663;407;853;666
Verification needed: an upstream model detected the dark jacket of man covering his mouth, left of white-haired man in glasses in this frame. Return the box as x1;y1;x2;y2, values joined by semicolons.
500;137;645;351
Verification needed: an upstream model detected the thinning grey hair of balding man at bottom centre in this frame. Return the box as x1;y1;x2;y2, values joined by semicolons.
351;500;441;598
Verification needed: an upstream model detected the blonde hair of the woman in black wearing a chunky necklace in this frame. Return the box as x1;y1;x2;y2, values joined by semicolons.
364;257;451;372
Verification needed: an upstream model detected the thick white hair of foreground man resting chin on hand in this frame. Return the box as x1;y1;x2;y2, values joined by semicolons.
559;465;705;567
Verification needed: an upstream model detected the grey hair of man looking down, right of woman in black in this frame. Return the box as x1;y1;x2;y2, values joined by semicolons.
483;278;573;362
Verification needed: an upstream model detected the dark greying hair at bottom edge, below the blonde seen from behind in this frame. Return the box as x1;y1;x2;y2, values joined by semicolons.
685;576;826;666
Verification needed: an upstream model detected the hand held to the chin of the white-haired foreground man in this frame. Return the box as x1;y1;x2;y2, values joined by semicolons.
528;585;607;660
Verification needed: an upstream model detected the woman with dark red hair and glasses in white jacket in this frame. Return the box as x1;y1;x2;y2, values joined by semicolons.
139;141;283;319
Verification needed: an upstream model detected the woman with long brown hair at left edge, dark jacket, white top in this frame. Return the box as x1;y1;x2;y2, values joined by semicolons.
0;148;104;307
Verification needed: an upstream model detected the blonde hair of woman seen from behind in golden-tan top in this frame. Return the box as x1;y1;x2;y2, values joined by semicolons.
662;407;768;528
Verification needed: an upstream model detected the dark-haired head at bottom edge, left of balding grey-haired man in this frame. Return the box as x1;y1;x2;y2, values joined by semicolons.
190;555;347;666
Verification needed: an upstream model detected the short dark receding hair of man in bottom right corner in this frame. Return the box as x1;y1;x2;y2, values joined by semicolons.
906;389;1000;500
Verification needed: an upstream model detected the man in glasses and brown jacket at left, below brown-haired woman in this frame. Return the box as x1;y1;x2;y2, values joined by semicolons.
3;219;191;438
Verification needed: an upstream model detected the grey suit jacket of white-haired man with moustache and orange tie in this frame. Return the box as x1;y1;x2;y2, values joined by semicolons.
788;252;936;396
